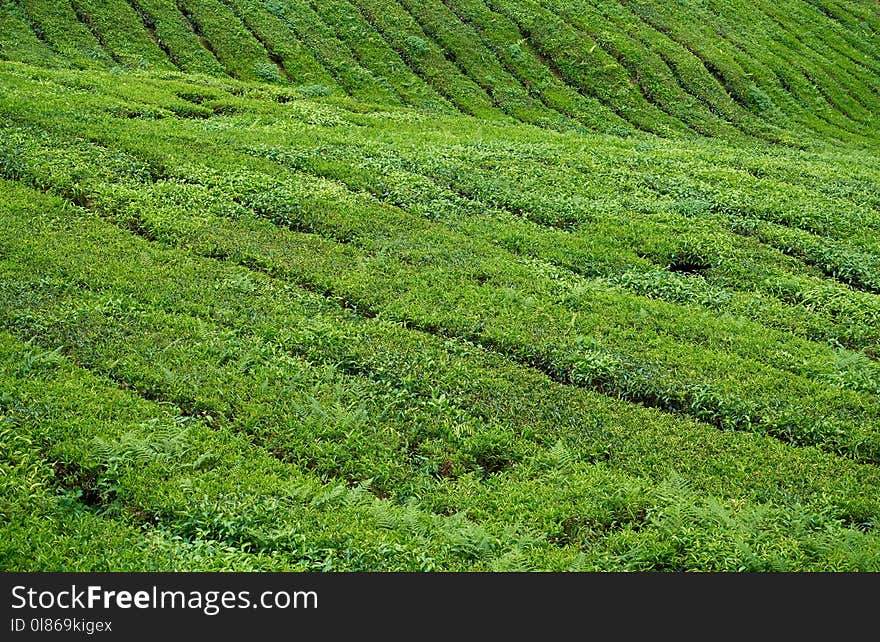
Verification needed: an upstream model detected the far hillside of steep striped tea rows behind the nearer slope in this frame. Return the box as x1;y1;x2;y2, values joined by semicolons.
0;0;880;143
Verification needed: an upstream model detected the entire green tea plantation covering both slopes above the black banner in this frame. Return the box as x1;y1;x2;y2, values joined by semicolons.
0;0;880;571
